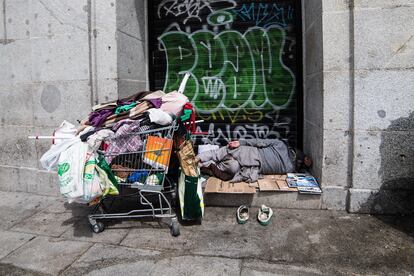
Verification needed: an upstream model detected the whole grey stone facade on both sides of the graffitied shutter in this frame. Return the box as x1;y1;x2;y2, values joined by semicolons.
0;0;414;213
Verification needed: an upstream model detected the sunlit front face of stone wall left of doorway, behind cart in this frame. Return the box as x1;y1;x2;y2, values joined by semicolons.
0;0;118;195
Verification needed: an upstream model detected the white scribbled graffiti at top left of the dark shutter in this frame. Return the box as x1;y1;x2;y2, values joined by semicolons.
158;0;236;24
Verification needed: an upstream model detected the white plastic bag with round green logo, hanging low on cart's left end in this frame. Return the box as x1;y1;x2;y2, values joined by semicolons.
58;140;88;199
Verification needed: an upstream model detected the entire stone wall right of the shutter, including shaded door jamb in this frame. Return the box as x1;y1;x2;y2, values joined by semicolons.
304;0;414;213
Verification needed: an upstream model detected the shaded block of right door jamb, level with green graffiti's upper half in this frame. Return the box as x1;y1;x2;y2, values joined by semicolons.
305;15;324;75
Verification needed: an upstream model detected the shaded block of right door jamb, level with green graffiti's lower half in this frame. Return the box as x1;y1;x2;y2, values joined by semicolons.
304;73;324;128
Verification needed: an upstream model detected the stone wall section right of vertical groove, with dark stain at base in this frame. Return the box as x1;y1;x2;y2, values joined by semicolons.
349;0;414;213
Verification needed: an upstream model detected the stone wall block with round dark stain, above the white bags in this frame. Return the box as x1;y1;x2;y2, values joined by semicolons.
33;80;91;129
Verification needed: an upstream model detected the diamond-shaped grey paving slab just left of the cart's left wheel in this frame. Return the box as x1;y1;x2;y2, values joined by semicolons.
11;211;76;237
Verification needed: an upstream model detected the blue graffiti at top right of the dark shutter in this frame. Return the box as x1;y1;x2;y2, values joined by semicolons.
233;3;293;28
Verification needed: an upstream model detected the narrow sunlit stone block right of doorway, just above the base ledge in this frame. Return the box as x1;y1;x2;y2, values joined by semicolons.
322;129;352;187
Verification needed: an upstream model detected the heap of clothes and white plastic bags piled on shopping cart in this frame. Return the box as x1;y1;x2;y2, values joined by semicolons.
40;91;188;203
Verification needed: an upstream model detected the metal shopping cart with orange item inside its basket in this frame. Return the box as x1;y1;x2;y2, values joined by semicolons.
88;120;180;236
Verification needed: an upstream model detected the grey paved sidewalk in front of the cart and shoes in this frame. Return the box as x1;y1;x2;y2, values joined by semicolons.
0;192;414;275
